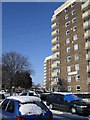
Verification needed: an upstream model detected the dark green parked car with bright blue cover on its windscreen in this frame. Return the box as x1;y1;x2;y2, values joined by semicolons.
46;92;90;115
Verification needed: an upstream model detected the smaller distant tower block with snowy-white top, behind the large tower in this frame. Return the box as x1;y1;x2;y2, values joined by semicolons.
44;56;53;90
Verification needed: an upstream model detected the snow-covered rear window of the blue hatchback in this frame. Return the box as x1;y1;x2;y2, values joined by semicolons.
19;101;48;115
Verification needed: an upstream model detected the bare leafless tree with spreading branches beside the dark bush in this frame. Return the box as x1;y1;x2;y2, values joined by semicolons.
2;51;32;94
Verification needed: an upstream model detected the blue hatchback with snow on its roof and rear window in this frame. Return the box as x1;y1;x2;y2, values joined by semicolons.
0;96;53;120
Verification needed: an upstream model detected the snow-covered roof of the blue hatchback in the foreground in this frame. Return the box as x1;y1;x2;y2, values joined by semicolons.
7;96;41;103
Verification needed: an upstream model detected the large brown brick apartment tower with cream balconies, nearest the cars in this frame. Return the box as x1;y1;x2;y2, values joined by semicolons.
51;0;90;92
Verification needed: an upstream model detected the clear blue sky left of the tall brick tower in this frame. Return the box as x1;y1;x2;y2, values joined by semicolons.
2;2;62;85
